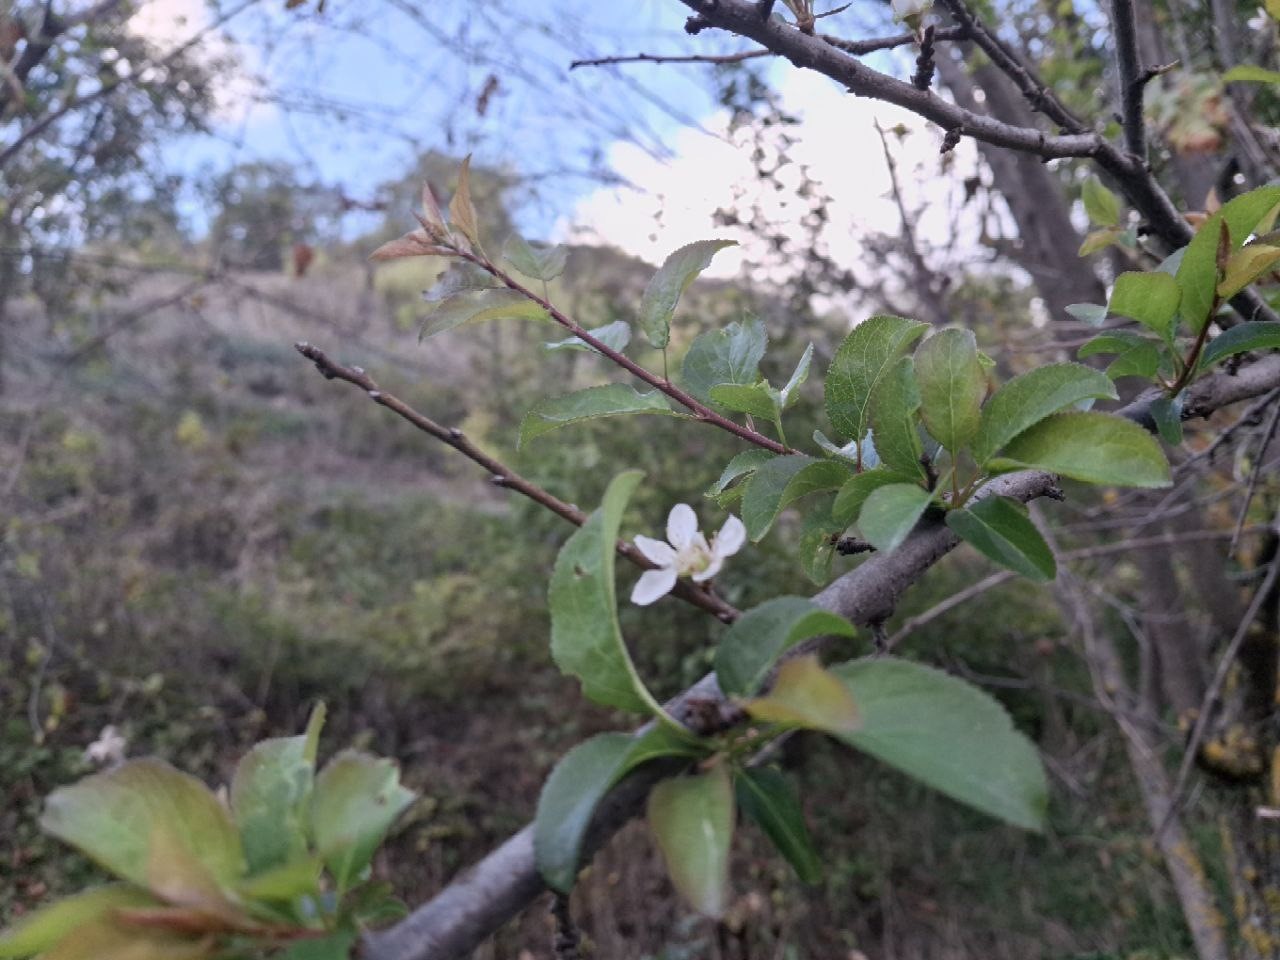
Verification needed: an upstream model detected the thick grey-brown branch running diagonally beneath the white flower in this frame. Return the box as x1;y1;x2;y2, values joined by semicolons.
362;353;1280;960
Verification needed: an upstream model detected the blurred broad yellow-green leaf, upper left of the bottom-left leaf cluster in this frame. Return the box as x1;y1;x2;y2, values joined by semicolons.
40;758;244;886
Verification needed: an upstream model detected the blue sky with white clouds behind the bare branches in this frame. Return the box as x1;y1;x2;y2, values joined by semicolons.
122;0;974;275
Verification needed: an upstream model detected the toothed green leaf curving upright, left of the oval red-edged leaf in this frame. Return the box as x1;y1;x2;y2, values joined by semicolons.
826;315;928;448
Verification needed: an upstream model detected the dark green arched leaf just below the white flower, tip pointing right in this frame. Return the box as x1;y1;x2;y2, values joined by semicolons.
716;596;854;696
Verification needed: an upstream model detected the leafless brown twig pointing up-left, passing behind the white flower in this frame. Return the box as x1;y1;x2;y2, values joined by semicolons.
294;343;739;623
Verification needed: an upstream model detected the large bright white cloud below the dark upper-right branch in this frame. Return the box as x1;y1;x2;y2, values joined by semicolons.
557;72;979;289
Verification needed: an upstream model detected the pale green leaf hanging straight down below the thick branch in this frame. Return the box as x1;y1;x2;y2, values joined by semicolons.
649;763;733;918
